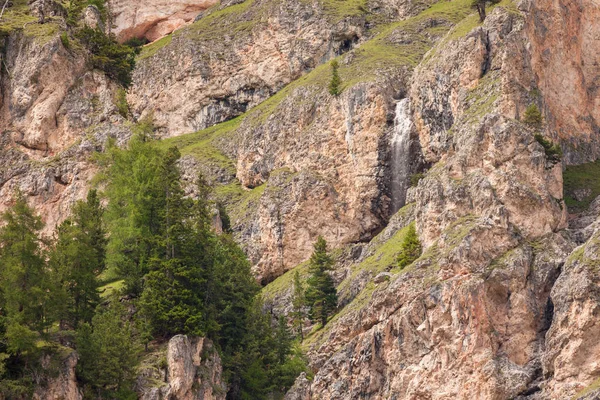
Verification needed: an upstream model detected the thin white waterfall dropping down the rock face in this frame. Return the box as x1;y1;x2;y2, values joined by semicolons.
391;99;412;213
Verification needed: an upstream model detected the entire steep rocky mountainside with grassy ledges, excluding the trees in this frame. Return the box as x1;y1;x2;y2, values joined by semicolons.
0;0;600;400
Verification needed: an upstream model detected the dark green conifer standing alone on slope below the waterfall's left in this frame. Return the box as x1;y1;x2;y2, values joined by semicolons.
306;236;337;326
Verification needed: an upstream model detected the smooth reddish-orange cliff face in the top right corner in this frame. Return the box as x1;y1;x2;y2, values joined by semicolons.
526;0;600;163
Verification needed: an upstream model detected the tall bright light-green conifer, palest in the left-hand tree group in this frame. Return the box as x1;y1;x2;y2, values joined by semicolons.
99;120;166;296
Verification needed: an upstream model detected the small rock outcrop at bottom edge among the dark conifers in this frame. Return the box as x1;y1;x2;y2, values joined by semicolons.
137;335;227;400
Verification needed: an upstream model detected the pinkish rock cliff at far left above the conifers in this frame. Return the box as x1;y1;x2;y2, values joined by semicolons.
0;23;130;233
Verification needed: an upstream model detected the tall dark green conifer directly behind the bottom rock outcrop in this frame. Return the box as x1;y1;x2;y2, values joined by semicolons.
141;153;211;337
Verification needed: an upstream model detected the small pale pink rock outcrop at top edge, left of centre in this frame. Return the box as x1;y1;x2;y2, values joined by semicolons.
108;0;218;42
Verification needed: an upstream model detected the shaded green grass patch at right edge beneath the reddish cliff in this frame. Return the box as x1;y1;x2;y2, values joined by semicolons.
563;160;600;213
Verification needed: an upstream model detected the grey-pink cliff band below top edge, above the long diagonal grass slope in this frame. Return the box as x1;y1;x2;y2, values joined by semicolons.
129;0;365;136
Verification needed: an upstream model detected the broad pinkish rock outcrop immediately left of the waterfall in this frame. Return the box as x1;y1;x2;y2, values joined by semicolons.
237;80;392;281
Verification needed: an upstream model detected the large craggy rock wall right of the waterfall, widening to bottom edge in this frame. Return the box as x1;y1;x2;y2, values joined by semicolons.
288;3;600;399
